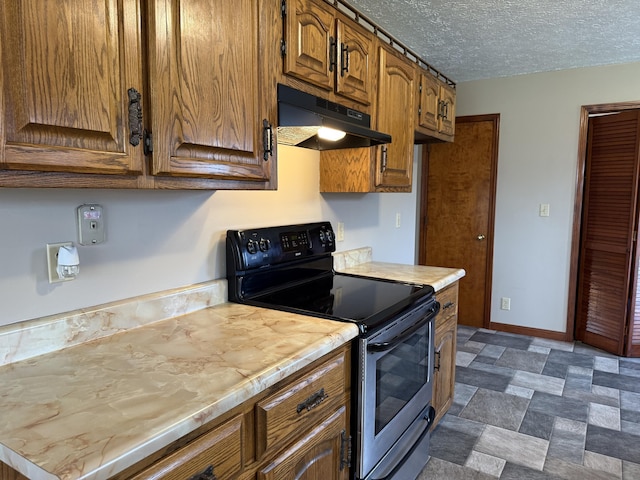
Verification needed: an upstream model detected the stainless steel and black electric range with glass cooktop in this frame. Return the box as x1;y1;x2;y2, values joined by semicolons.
226;222;440;480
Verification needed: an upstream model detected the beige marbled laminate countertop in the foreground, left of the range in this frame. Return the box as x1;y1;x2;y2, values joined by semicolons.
0;303;358;480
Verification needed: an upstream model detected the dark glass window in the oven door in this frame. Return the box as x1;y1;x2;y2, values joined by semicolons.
375;324;430;435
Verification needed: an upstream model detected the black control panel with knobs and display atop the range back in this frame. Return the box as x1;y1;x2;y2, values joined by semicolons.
227;222;336;272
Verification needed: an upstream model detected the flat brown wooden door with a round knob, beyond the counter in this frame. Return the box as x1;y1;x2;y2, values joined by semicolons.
420;114;500;327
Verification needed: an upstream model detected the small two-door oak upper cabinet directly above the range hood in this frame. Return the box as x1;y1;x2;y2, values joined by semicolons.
283;0;374;105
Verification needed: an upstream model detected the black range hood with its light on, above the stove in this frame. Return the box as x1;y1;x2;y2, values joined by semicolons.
278;84;391;150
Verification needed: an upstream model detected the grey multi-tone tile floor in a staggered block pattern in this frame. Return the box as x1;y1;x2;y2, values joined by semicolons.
417;326;640;480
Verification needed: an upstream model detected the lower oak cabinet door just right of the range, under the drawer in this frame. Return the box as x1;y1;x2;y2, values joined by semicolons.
433;315;457;426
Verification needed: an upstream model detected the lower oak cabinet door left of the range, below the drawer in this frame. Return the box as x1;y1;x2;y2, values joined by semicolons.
258;406;349;480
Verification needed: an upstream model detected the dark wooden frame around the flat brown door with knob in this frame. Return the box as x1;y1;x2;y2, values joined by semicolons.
418;113;500;328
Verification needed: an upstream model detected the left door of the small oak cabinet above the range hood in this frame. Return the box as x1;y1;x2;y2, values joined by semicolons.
284;0;336;90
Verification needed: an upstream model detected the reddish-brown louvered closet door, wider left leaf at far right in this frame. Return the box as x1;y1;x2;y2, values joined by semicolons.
576;111;640;355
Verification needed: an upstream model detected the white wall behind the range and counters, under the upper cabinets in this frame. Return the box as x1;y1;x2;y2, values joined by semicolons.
0;146;418;325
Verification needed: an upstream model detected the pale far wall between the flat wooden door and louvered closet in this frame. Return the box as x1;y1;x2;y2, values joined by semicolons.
457;63;640;332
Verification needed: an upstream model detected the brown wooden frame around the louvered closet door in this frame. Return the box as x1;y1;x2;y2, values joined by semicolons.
565;102;640;342
